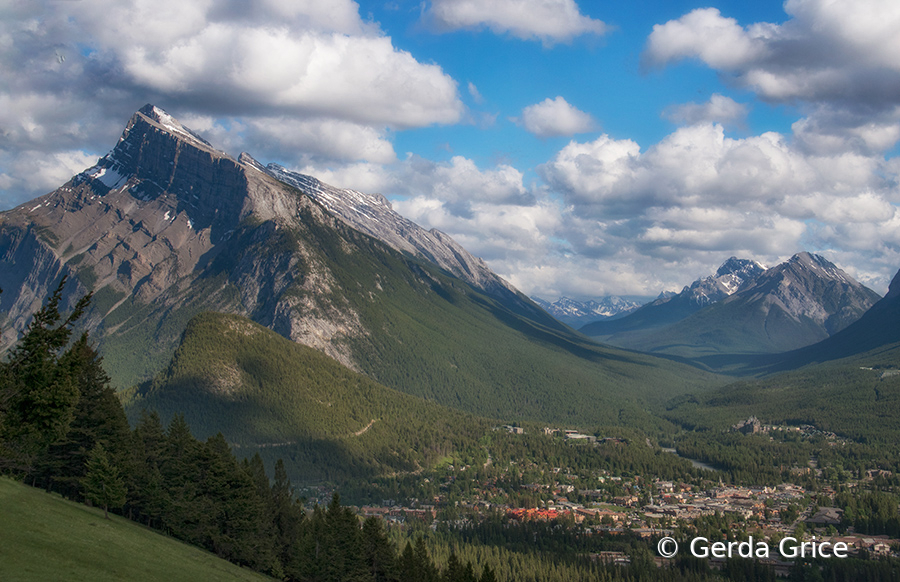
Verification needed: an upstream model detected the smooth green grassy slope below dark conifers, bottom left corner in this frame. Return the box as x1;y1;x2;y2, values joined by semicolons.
0;478;271;582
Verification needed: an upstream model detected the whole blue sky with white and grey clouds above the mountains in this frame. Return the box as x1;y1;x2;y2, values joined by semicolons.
0;0;900;299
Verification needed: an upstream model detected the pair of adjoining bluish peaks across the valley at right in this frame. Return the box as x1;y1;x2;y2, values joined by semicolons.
581;252;879;358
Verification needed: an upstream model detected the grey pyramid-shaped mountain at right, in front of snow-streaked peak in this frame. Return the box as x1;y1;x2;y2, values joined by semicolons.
592;252;879;361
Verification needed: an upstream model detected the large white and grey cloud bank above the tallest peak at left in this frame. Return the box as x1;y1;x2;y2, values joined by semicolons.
0;0;465;206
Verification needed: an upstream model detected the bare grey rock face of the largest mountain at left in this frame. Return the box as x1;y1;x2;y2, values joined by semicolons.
0;105;384;384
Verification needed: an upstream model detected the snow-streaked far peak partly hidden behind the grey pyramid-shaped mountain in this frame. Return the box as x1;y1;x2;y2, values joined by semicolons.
580;257;765;345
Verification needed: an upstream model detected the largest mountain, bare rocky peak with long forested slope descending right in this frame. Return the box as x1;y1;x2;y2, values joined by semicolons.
0;105;721;422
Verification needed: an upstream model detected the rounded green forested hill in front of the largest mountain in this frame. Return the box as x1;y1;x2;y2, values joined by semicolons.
127;313;491;478
